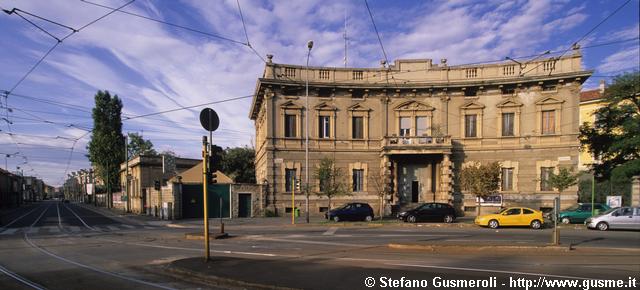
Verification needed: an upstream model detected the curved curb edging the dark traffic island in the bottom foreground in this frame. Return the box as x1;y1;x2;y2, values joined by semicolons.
164;264;297;290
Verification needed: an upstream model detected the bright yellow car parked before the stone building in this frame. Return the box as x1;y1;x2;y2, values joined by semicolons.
474;207;544;229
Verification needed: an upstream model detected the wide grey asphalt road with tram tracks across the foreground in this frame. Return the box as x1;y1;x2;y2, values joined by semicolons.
0;201;640;289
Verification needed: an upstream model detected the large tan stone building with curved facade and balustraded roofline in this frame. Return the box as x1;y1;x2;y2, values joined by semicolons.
250;50;592;215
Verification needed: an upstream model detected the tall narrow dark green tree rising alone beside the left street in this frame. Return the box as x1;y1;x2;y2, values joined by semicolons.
87;91;125;206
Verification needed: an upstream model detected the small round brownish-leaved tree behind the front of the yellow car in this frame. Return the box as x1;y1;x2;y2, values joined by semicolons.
460;162;500;215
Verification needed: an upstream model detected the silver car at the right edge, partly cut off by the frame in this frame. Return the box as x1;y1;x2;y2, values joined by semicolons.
584;206;640;231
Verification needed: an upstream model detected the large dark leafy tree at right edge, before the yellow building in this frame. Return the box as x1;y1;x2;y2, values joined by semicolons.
579;72;640;180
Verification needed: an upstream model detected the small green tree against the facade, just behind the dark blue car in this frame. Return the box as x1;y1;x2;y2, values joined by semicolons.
315;157;349;209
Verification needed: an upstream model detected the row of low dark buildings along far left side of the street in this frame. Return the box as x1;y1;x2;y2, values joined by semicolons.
0;168;56;208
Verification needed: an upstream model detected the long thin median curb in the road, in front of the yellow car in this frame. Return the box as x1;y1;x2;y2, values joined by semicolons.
387;243;574;252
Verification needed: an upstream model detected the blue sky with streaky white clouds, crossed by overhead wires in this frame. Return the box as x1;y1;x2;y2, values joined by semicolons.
0;0;640;185
